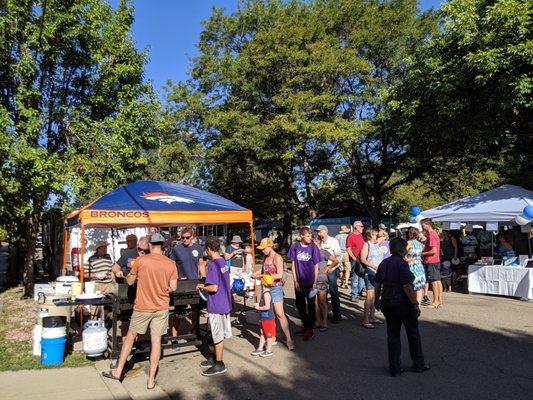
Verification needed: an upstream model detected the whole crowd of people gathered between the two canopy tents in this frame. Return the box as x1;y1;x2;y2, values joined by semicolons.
90;221;444;389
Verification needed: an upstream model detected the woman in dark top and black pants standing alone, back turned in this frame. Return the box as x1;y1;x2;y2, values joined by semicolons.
375;238;429;376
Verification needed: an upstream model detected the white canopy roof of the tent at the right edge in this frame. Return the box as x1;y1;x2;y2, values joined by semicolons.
422;185;533;223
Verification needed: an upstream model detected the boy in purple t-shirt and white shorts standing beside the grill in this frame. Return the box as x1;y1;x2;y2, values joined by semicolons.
196;237;232;376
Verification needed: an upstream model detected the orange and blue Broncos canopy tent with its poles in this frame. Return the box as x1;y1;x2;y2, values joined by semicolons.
63;181;254;281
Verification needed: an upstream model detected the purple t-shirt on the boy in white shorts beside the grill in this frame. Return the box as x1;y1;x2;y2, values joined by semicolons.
205;257;231;314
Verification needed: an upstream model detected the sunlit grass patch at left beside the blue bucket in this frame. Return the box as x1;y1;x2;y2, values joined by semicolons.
0;288;92;371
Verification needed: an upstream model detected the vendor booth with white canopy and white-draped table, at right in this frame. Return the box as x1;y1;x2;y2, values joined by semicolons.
422;185;533;299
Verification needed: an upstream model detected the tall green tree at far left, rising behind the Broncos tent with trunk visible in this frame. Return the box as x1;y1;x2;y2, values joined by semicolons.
0;0;157;294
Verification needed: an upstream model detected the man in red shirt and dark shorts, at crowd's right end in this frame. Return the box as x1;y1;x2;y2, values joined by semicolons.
421;219;442;308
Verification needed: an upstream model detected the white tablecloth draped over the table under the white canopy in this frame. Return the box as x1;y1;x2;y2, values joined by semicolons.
468;265;533;300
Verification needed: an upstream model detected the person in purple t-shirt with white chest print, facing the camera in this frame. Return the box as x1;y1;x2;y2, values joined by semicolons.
288;227;321;342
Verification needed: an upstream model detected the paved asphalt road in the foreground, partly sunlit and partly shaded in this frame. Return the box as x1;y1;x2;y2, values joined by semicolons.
130;278;533;400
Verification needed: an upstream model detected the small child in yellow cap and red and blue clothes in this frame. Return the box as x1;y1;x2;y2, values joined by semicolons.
252;275;276;357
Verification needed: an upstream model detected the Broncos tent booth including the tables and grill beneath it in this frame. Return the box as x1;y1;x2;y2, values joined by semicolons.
54;181;254;362
